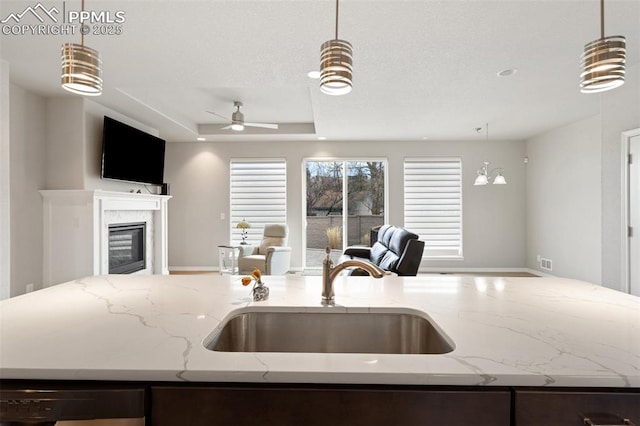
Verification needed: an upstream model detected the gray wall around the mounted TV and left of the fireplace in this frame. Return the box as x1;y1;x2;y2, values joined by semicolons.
0;92;157;299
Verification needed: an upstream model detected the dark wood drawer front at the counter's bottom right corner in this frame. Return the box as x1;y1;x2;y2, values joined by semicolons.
514;389;640;426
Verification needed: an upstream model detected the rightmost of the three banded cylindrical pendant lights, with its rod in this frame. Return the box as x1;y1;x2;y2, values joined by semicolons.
580;0;626;93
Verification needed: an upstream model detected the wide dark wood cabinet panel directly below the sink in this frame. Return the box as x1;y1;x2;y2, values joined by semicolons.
151;385;511;426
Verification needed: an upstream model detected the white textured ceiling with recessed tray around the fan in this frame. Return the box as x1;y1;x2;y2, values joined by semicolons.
0;0;640;141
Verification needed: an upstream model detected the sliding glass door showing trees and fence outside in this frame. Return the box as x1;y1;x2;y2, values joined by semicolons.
304;160;387;268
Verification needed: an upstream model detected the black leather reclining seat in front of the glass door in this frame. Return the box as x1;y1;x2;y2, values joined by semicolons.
339;225;424;276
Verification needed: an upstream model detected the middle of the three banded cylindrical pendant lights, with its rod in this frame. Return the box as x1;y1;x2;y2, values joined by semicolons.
320;0;353;95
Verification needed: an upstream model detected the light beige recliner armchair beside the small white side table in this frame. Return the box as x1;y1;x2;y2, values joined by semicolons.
238;224;291;275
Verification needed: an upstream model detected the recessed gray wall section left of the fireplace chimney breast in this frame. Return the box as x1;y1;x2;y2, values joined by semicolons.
10;85;46;296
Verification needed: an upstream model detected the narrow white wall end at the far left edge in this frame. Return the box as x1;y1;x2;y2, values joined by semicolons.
0;60;11;300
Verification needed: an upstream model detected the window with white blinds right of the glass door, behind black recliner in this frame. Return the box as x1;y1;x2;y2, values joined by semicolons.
404;158;462;258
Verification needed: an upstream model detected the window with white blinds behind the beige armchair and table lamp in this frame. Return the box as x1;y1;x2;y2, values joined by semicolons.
230;159;287;244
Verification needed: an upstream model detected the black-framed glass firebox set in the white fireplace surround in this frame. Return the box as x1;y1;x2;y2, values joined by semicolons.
109;222;146;274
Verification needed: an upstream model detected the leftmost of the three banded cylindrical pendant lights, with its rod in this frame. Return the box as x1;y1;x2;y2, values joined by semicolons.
62;0;102;96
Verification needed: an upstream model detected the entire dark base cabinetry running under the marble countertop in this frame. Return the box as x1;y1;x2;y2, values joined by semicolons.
0;380;640;426
